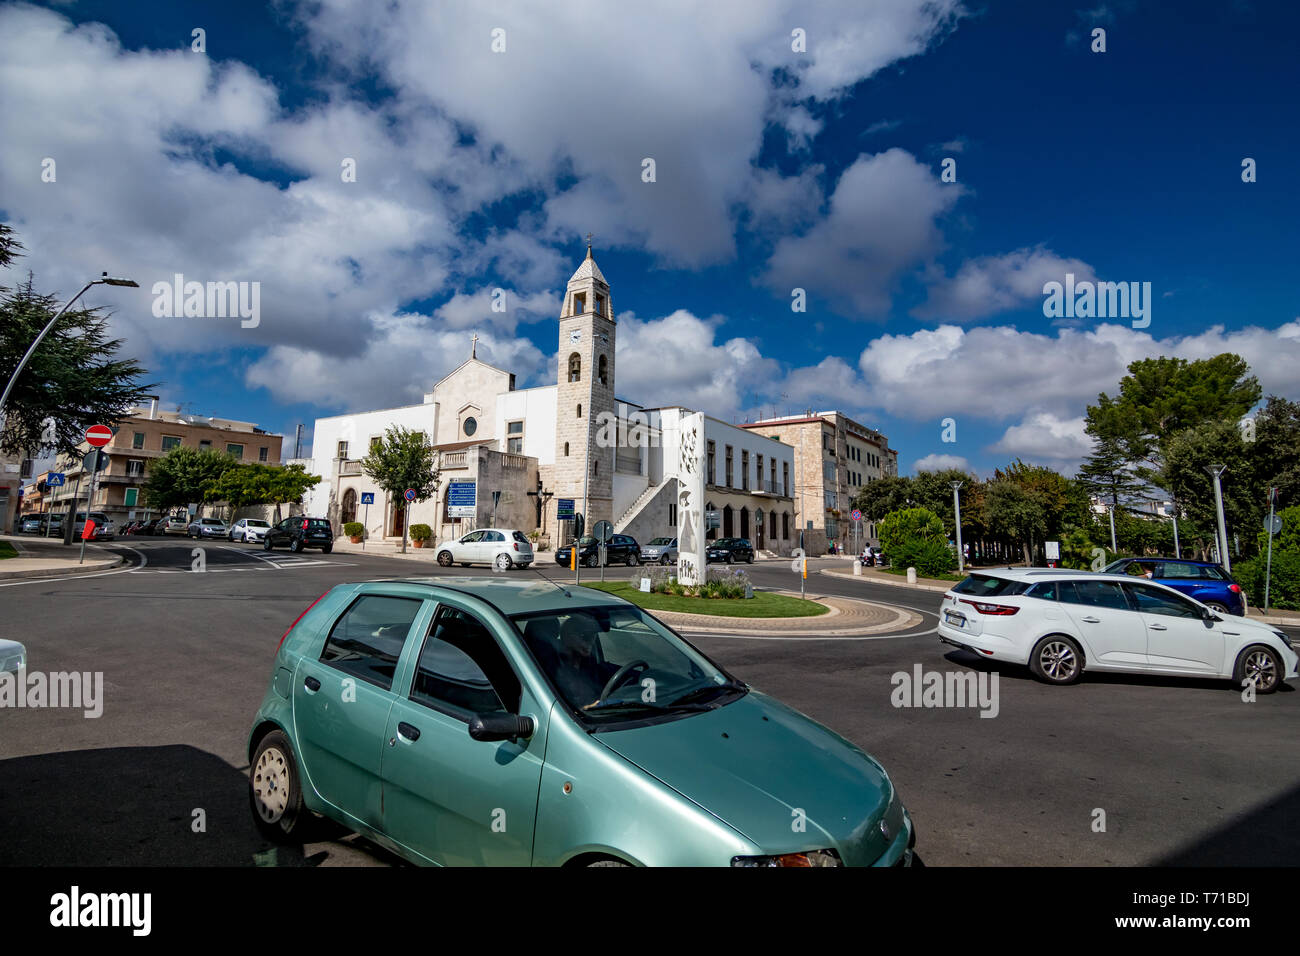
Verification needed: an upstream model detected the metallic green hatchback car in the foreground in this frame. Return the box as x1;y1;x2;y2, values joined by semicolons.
248;576;915;866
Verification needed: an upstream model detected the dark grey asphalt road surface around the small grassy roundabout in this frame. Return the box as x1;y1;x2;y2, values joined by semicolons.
0;538;1300;865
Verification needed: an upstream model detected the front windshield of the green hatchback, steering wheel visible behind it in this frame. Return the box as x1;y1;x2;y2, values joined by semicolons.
511;606;733;723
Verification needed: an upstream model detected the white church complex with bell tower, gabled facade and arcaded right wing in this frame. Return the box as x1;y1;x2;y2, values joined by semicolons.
304;246;798;561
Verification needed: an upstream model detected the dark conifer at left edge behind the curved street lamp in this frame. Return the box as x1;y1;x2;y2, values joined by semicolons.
0;277;155;455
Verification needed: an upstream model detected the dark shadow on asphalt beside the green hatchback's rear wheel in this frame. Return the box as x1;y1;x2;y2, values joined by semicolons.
0;745;394;866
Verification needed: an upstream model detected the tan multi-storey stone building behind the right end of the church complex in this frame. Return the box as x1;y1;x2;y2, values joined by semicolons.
742;410;898;554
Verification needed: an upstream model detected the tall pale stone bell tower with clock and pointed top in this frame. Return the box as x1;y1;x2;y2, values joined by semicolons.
555;243;618;532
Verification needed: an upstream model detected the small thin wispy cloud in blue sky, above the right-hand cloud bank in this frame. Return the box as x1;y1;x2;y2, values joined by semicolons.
913;246;1097;321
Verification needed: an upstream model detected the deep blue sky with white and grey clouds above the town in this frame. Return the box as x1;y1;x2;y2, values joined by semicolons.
0;0;1300;473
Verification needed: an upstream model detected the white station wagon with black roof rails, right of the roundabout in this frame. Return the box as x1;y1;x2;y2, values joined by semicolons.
939;568;1297;693
